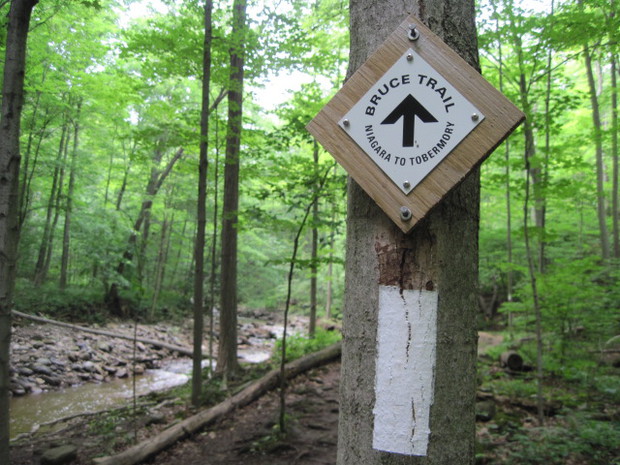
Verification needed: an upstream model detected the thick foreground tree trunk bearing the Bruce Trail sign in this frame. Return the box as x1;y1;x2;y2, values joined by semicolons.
338;0;479;465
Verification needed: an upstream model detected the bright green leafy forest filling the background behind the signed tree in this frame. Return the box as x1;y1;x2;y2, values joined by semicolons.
0;0;620;464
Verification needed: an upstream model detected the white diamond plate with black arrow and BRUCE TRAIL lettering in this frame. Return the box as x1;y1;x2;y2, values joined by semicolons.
338;49;484;194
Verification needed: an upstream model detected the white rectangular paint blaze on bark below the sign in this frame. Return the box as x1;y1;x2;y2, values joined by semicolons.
373;286;438;456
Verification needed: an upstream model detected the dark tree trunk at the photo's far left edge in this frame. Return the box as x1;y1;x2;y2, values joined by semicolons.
0;0;37;464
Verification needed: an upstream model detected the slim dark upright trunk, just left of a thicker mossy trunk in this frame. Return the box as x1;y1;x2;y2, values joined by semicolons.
192;0;213;407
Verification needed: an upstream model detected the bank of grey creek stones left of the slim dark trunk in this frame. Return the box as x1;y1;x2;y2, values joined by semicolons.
10;321;190;396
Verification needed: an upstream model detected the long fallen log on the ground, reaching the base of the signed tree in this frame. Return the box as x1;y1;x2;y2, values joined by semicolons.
94;343;341;465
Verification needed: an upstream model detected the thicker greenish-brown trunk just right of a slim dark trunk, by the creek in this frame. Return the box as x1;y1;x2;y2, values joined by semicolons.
217;0;247;376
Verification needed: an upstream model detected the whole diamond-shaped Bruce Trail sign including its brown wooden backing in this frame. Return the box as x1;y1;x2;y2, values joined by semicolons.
307;16;525;233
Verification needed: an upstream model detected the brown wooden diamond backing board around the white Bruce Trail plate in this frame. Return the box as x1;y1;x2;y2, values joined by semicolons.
306;15;525;233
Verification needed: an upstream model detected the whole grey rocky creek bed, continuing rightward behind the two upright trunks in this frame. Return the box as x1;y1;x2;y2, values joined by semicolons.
10;310;307;396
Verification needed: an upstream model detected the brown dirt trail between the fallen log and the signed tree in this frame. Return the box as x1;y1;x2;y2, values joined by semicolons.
151;362;340;465
